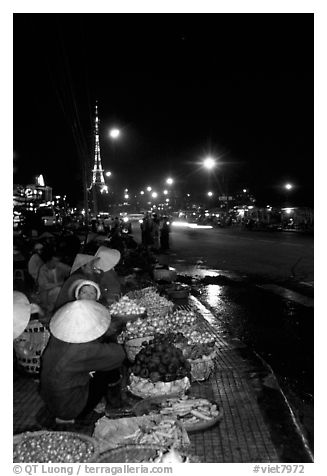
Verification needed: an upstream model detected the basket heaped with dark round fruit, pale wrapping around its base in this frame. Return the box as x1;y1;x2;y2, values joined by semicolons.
129;335;191;398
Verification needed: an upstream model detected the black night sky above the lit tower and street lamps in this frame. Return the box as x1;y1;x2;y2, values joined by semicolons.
13;13;314;206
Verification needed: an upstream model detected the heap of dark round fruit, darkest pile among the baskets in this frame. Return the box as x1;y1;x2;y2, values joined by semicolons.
131;336;191;382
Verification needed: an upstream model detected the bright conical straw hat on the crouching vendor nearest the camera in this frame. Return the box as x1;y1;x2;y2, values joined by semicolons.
50;299;111;344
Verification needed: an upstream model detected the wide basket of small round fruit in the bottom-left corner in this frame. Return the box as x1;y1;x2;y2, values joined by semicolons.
13;431;100;463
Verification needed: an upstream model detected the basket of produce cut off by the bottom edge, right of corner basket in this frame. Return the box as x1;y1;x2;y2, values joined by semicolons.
98;445;201;464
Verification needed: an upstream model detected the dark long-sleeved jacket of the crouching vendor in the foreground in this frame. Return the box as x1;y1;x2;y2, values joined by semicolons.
40;336;125;419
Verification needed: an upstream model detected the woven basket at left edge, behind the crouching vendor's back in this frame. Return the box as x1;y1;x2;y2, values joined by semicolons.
14;320;50;374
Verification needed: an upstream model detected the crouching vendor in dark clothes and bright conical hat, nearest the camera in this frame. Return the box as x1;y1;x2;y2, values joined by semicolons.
40;299;125;425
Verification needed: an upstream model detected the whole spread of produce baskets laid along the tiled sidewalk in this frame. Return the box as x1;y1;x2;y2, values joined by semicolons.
14;285;223;462
